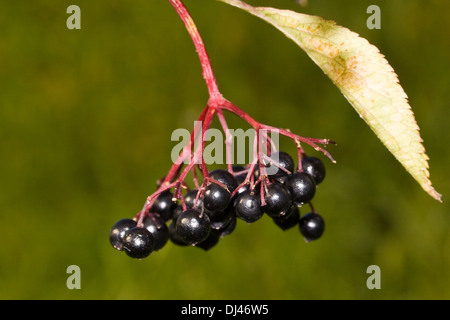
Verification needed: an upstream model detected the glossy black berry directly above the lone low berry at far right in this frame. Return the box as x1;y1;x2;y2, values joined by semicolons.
286;171;316;206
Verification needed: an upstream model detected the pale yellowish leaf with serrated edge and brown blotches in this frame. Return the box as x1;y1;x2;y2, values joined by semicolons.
220;0;441;201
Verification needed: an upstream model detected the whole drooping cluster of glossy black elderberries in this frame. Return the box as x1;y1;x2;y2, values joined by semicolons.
109;151;325;259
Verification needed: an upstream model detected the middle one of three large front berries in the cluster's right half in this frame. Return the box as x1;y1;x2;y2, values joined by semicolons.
263;182;292;217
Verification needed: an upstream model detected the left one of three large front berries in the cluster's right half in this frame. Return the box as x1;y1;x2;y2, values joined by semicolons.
234;190;264;223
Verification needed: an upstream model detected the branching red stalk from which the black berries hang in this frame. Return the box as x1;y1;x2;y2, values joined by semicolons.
135;0;335;227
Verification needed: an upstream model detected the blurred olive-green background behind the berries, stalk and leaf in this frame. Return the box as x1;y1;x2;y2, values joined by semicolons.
0;0;450;299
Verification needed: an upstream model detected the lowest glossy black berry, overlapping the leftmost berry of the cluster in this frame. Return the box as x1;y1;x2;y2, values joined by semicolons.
123;227;154;259
